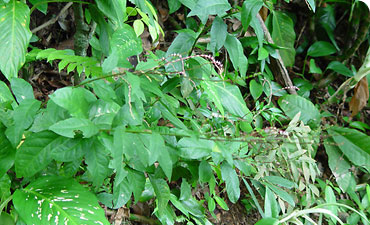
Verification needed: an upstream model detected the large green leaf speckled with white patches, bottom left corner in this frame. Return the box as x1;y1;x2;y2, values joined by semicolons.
13;176;109;225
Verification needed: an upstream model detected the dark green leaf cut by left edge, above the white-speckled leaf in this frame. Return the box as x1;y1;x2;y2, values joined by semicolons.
0;129;15;178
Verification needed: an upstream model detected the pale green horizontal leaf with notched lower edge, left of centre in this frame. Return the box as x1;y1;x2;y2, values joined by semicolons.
49;118;99;138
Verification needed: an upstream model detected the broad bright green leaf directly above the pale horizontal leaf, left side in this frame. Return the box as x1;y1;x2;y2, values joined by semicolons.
50;87;96;118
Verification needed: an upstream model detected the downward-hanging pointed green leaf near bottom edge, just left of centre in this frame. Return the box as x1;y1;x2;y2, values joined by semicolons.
149;176;171;214
